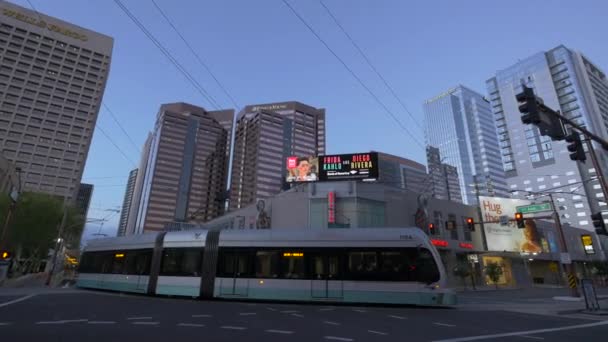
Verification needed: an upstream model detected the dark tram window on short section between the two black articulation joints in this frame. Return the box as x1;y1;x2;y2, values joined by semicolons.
160;248;203;277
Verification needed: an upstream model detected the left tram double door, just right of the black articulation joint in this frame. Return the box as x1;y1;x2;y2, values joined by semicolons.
221;252;251;296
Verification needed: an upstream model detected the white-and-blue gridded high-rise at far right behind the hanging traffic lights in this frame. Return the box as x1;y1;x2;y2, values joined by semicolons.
486;45;608;229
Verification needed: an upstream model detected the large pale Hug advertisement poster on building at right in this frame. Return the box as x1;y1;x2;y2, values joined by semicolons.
479;196;543;253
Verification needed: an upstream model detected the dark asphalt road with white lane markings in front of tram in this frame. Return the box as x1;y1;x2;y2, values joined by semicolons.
0;290;608;342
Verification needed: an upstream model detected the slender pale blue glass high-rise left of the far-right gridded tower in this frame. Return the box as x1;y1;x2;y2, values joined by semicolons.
424;85;509;204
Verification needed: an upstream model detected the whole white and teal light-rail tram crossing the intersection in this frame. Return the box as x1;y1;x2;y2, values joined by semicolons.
77;228;456;305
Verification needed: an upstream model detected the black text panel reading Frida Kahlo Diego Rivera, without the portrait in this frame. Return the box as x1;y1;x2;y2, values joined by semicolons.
319;152;378;181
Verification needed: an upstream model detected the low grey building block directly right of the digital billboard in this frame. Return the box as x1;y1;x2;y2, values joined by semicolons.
378;152;428;193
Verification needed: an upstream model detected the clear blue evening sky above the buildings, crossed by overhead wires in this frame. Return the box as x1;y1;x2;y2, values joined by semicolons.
11;0;608;243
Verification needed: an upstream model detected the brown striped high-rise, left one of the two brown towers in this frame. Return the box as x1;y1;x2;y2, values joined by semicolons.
131;103;234;234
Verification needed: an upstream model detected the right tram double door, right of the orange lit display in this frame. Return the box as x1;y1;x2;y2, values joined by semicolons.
310;253;344;299
